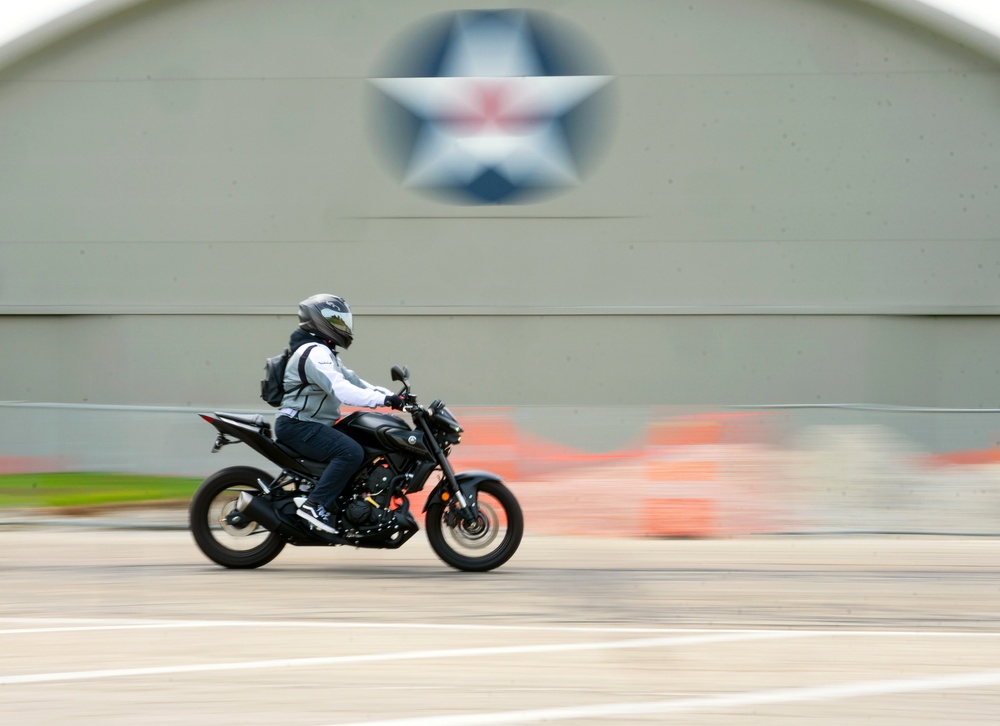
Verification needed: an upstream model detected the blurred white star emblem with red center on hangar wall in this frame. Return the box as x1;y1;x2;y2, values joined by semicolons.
371;11;612;203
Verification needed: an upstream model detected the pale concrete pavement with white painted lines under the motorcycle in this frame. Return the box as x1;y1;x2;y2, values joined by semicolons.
0;522;1000;726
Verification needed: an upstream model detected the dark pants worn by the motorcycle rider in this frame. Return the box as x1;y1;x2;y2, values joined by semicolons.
274;416;364;511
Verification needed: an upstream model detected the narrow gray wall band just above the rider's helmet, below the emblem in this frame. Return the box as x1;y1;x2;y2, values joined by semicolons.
0;240;1000;315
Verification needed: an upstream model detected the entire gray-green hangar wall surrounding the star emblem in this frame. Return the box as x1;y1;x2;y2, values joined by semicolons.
0;0;1000;408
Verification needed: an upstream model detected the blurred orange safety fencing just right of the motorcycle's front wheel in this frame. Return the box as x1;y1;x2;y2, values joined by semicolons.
451;411;781;537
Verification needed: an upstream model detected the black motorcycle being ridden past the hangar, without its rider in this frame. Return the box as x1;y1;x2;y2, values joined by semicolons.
190;366;524;572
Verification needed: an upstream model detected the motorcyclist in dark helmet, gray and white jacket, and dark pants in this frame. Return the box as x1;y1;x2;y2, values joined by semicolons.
274;294;403;534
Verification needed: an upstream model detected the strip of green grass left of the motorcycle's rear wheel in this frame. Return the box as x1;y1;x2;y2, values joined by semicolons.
0;472;201;509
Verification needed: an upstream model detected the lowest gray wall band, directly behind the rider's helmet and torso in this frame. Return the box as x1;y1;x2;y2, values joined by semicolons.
0;315;1000;409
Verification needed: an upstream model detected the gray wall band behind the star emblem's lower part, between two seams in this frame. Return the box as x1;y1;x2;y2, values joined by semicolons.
0;55;1000;252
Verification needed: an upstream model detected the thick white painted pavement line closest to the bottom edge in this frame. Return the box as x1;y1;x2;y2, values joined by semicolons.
330;671;1000;726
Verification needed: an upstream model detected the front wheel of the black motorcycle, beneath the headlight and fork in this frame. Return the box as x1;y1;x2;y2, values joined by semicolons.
426;480;524;572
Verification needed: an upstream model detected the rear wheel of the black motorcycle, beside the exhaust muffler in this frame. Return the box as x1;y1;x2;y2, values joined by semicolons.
190;466;285;570
